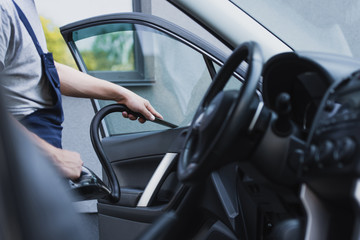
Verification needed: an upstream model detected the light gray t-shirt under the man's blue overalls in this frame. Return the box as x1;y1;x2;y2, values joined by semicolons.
0;0;52;119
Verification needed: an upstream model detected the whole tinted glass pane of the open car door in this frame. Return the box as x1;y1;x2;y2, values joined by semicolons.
73;23;215;135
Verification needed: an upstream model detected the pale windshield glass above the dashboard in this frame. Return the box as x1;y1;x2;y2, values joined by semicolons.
231;0;360;58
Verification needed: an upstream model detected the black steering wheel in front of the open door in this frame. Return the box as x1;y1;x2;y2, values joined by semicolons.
178;42;263;182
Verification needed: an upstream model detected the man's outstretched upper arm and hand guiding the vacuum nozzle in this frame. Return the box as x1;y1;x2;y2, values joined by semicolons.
55;63;162;122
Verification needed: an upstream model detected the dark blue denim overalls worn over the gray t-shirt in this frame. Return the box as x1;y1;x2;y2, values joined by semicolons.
13;0;64;148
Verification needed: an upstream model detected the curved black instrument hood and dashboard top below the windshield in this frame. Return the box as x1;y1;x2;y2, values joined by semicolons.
263;53;360;140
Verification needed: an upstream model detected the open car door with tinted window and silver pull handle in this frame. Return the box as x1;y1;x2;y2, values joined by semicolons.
60;13;241;239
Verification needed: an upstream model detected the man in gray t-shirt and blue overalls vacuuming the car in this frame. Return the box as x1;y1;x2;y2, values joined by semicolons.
0;0;162;179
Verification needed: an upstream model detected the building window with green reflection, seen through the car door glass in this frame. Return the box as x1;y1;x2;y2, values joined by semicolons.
73;23;145;85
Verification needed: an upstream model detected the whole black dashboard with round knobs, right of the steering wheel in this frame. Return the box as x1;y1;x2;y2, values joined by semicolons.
253;53;360;188
